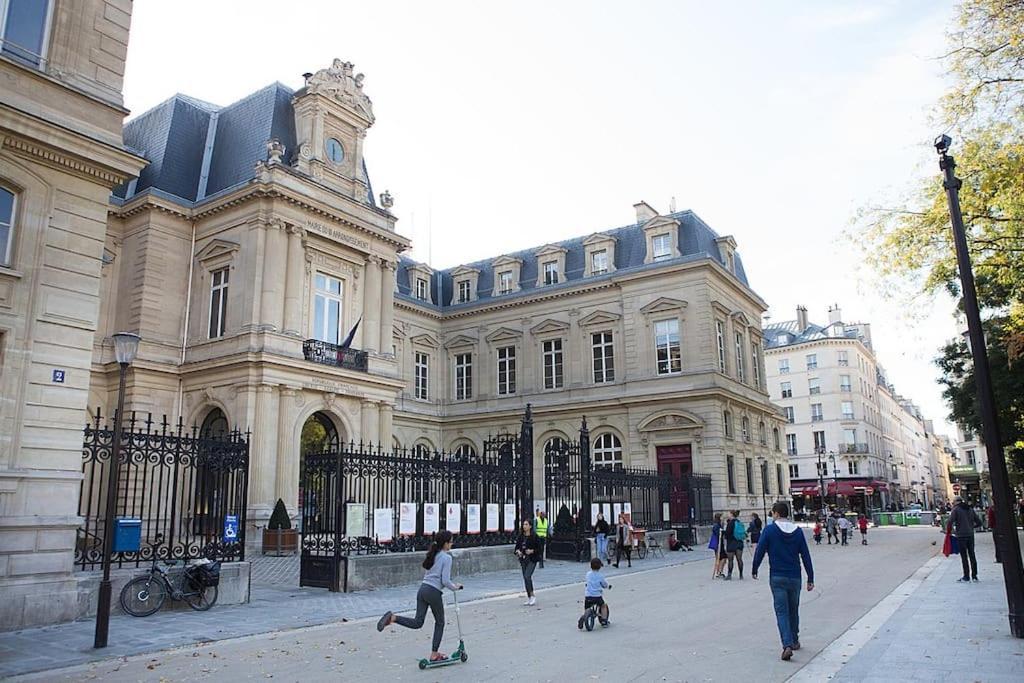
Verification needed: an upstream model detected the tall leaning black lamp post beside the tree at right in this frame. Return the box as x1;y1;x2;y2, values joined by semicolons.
935;135;1024;638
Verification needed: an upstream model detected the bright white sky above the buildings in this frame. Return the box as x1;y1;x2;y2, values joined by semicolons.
124;0;958;436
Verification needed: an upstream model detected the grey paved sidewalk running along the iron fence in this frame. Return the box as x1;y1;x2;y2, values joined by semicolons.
0;549;712;678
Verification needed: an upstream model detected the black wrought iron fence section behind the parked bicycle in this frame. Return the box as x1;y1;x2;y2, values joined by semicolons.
75;410;249;569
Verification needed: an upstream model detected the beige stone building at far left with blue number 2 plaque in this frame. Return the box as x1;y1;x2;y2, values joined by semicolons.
0;0;143;629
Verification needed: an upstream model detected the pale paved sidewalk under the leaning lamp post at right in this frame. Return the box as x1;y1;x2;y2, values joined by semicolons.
794;533;1024;683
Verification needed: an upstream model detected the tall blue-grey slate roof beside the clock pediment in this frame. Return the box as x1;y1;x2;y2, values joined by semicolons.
114;83;376;206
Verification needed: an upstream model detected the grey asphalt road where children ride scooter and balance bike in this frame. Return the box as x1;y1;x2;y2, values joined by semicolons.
32;528;942;683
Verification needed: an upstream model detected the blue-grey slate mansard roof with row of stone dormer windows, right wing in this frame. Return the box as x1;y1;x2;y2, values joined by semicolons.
396;211;750;310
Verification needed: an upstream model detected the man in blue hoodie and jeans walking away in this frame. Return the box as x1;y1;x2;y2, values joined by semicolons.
751;502;814;661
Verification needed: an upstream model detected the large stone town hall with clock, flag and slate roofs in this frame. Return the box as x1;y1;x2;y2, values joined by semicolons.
90;60;787;539
